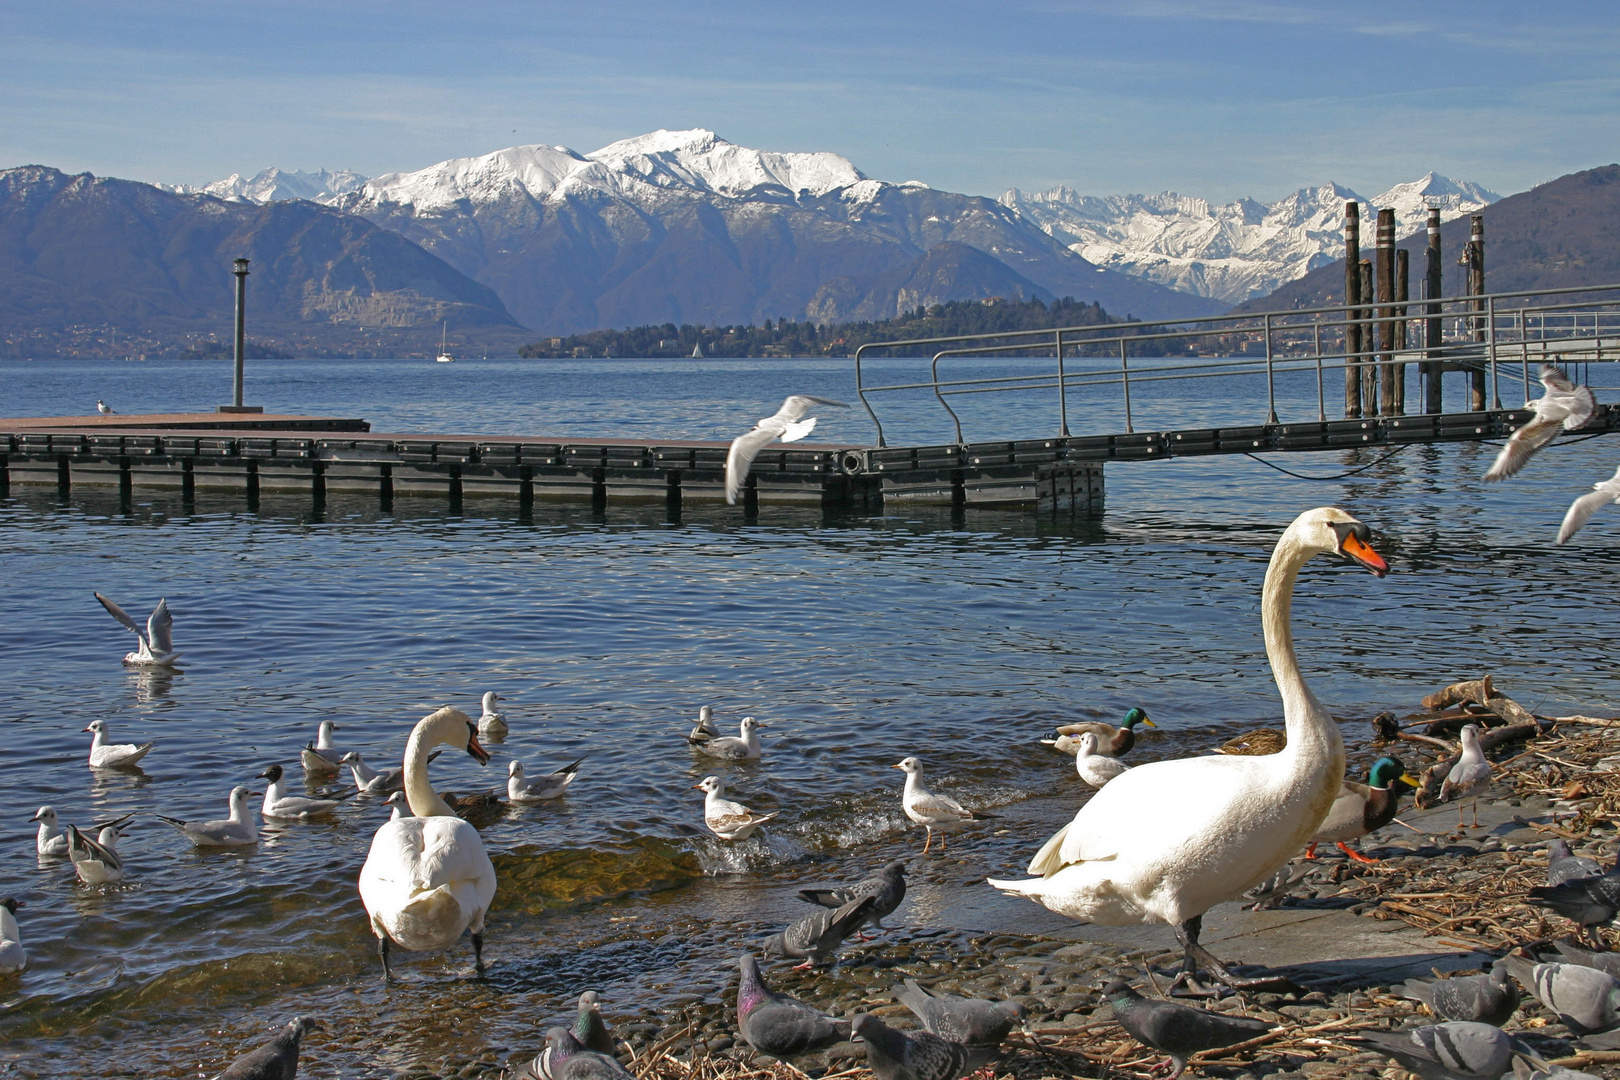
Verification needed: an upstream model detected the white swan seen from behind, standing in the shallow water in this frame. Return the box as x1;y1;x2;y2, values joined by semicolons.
360;706;496;981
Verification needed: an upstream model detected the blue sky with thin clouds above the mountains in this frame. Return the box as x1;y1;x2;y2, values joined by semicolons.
0;0;1620;199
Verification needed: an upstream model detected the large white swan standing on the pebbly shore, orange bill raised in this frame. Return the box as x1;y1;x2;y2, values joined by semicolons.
990;507;1388;988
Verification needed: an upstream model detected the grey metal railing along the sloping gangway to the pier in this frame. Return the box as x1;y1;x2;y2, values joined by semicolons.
855;285;1620;447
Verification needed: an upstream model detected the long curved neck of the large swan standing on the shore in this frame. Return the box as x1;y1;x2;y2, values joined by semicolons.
1260;529;1345;782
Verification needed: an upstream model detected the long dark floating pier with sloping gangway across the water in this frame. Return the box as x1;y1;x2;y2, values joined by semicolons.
0;405;1620;515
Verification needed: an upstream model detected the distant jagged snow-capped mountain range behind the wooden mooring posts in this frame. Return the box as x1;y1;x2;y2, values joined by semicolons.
1001;172;1502;303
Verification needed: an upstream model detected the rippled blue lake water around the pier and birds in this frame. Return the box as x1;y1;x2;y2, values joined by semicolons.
0;359;1620;1077
